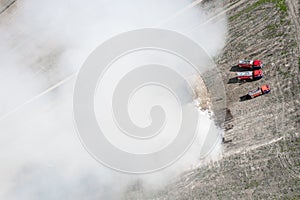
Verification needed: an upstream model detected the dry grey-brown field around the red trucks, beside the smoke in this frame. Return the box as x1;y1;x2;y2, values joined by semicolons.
125;0;300;200
